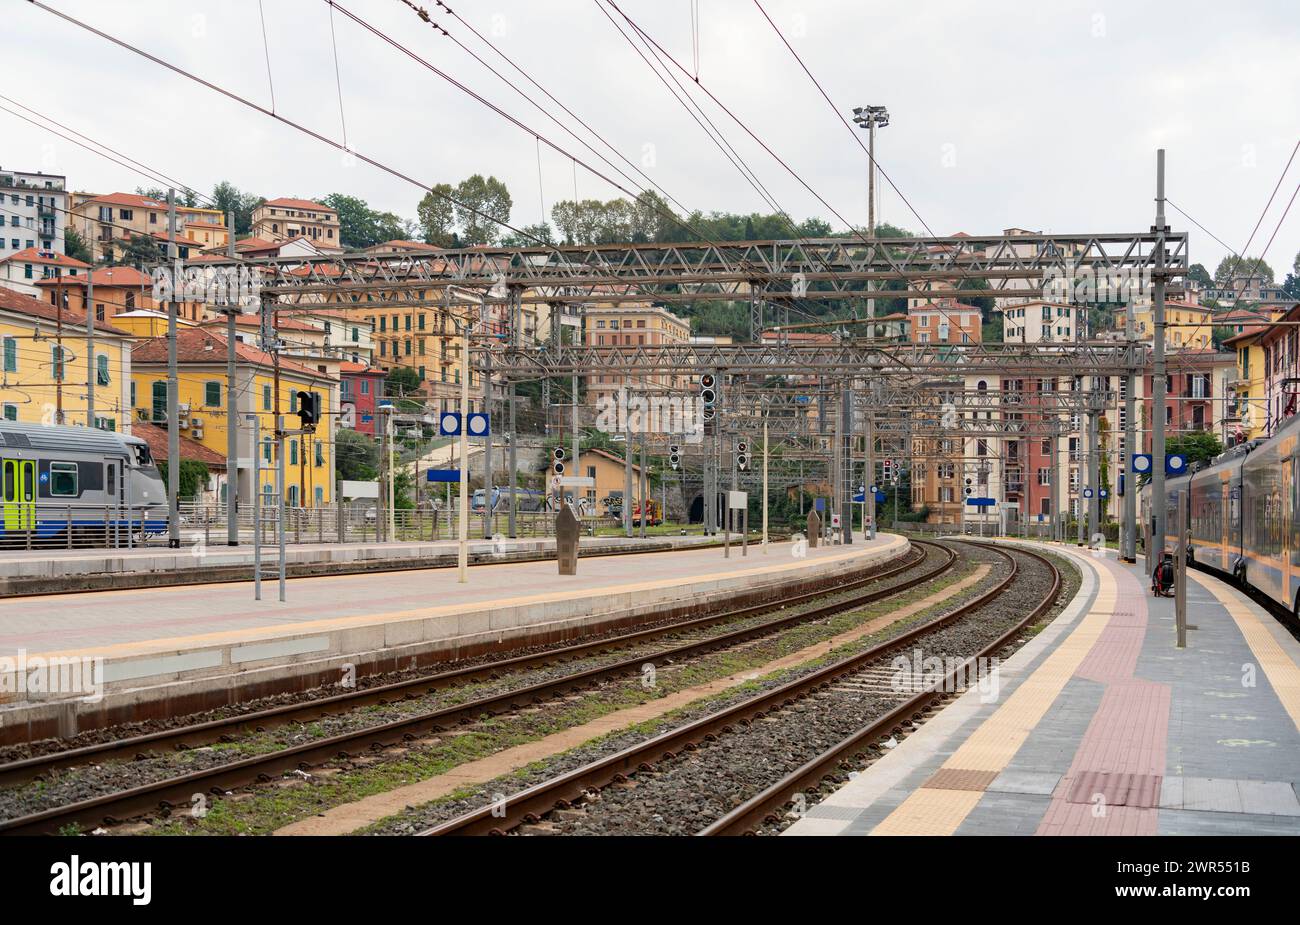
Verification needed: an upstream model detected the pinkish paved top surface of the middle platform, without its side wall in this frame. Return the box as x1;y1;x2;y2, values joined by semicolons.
0;535;907;657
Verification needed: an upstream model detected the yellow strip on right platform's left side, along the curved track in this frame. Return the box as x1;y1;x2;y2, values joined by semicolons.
871;553;1118;835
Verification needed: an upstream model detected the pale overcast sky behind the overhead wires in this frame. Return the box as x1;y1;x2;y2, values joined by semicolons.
10;0;1300;272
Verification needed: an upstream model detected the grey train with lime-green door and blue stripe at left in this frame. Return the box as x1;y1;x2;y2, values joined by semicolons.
0;421;168;550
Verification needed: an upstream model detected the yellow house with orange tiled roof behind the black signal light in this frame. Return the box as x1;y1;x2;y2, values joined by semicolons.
131;327;339;508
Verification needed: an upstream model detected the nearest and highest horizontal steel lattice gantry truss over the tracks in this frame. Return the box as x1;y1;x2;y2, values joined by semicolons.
211;233;1187;307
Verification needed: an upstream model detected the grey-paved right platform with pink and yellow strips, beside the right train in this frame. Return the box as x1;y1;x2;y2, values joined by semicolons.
785;546;1300;835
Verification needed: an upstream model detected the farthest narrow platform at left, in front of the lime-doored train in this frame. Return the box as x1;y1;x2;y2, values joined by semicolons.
0;534;718;596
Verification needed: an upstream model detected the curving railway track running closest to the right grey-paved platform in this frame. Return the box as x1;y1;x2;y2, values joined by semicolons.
420;544;1061;835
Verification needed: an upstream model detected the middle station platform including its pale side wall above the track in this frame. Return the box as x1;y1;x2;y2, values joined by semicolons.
0;535;910;742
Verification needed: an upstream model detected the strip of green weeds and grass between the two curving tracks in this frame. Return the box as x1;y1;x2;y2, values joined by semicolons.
148;564;987;835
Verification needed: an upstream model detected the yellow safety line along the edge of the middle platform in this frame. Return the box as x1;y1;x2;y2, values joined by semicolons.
29;537;907;659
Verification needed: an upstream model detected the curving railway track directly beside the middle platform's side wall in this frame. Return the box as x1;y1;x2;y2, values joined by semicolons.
0;542;957;834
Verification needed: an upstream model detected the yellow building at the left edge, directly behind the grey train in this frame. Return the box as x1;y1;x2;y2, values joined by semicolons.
0;288;131;431
